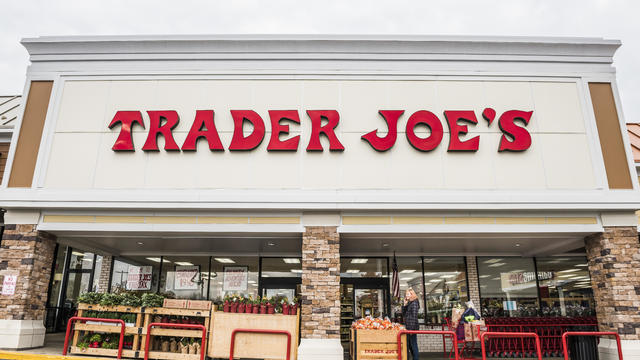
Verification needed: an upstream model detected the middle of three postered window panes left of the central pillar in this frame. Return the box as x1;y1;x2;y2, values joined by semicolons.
160;256;209;300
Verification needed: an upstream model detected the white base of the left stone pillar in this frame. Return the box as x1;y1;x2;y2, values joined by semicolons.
0;320;46;350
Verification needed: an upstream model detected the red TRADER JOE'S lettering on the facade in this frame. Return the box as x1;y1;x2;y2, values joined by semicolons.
109;108;533;152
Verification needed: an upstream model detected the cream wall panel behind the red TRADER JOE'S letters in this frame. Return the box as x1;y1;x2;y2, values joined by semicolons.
44;80;597;190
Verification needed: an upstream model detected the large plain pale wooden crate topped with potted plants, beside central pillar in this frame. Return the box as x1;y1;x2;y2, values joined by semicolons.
208;310;300;359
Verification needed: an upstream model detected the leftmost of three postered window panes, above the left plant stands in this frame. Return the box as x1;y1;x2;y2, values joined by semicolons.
111;256;161;292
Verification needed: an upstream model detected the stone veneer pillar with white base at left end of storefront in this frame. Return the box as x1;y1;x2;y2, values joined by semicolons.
0;224;56;349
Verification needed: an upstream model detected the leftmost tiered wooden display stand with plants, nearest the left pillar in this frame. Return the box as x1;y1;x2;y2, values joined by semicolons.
70;303;142;358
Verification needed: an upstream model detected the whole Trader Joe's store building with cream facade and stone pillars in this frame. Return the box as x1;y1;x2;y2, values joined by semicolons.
0;36;640;359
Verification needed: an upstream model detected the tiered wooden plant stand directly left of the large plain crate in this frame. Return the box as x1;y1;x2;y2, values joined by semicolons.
140;307;211;360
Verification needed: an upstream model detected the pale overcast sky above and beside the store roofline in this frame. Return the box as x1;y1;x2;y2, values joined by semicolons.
0;0;640;122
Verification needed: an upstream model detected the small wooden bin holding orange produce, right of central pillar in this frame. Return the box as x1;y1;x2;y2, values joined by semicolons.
349;329;407;360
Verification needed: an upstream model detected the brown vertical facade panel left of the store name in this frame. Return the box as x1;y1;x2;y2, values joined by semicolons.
9;81;52;187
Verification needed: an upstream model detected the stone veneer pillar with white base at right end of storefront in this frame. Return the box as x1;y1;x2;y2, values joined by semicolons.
585;226;640;360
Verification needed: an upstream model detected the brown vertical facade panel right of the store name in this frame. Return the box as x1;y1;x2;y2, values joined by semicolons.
589;83;633;189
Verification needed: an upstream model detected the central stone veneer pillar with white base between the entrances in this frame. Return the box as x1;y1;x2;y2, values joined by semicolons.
298;226;343;360
